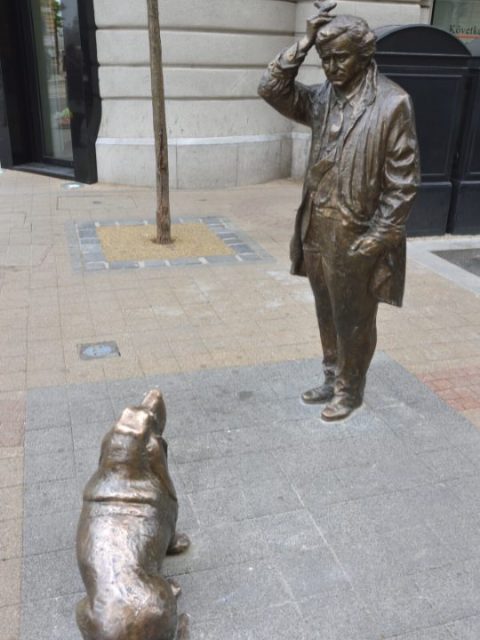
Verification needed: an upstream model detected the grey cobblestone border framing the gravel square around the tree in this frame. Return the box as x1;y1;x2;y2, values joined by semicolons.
66;216;273;271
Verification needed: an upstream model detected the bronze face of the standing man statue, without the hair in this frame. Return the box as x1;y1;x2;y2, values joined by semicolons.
319;33;366;93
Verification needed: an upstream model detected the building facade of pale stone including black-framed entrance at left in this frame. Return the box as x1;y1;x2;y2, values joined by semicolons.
0;0;472;189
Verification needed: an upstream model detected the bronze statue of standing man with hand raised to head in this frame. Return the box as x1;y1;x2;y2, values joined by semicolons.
259;0;419;420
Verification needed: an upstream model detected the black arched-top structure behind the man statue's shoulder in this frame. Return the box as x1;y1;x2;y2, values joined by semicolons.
377;6;480;235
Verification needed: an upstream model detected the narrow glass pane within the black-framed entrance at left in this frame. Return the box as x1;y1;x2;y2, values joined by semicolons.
30;0;73;166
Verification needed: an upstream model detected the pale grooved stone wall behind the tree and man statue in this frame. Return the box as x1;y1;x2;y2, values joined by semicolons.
95;0;429;189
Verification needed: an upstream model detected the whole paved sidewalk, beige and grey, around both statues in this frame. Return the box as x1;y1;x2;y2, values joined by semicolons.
0;172;480;640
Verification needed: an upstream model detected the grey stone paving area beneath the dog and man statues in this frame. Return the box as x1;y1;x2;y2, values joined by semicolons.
21;353;480;640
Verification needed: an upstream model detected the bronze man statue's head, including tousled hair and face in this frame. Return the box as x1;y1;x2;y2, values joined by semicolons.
315;15;375;93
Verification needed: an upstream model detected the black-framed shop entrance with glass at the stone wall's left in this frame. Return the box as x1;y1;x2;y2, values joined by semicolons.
0;0;100;183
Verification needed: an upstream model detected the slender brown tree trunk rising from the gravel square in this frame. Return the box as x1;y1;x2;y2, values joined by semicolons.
147;0;172;244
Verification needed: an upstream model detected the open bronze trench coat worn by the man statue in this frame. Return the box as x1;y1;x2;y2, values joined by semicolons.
259;49;420;306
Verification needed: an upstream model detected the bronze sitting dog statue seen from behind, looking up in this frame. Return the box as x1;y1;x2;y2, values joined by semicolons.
77;390;189;640
